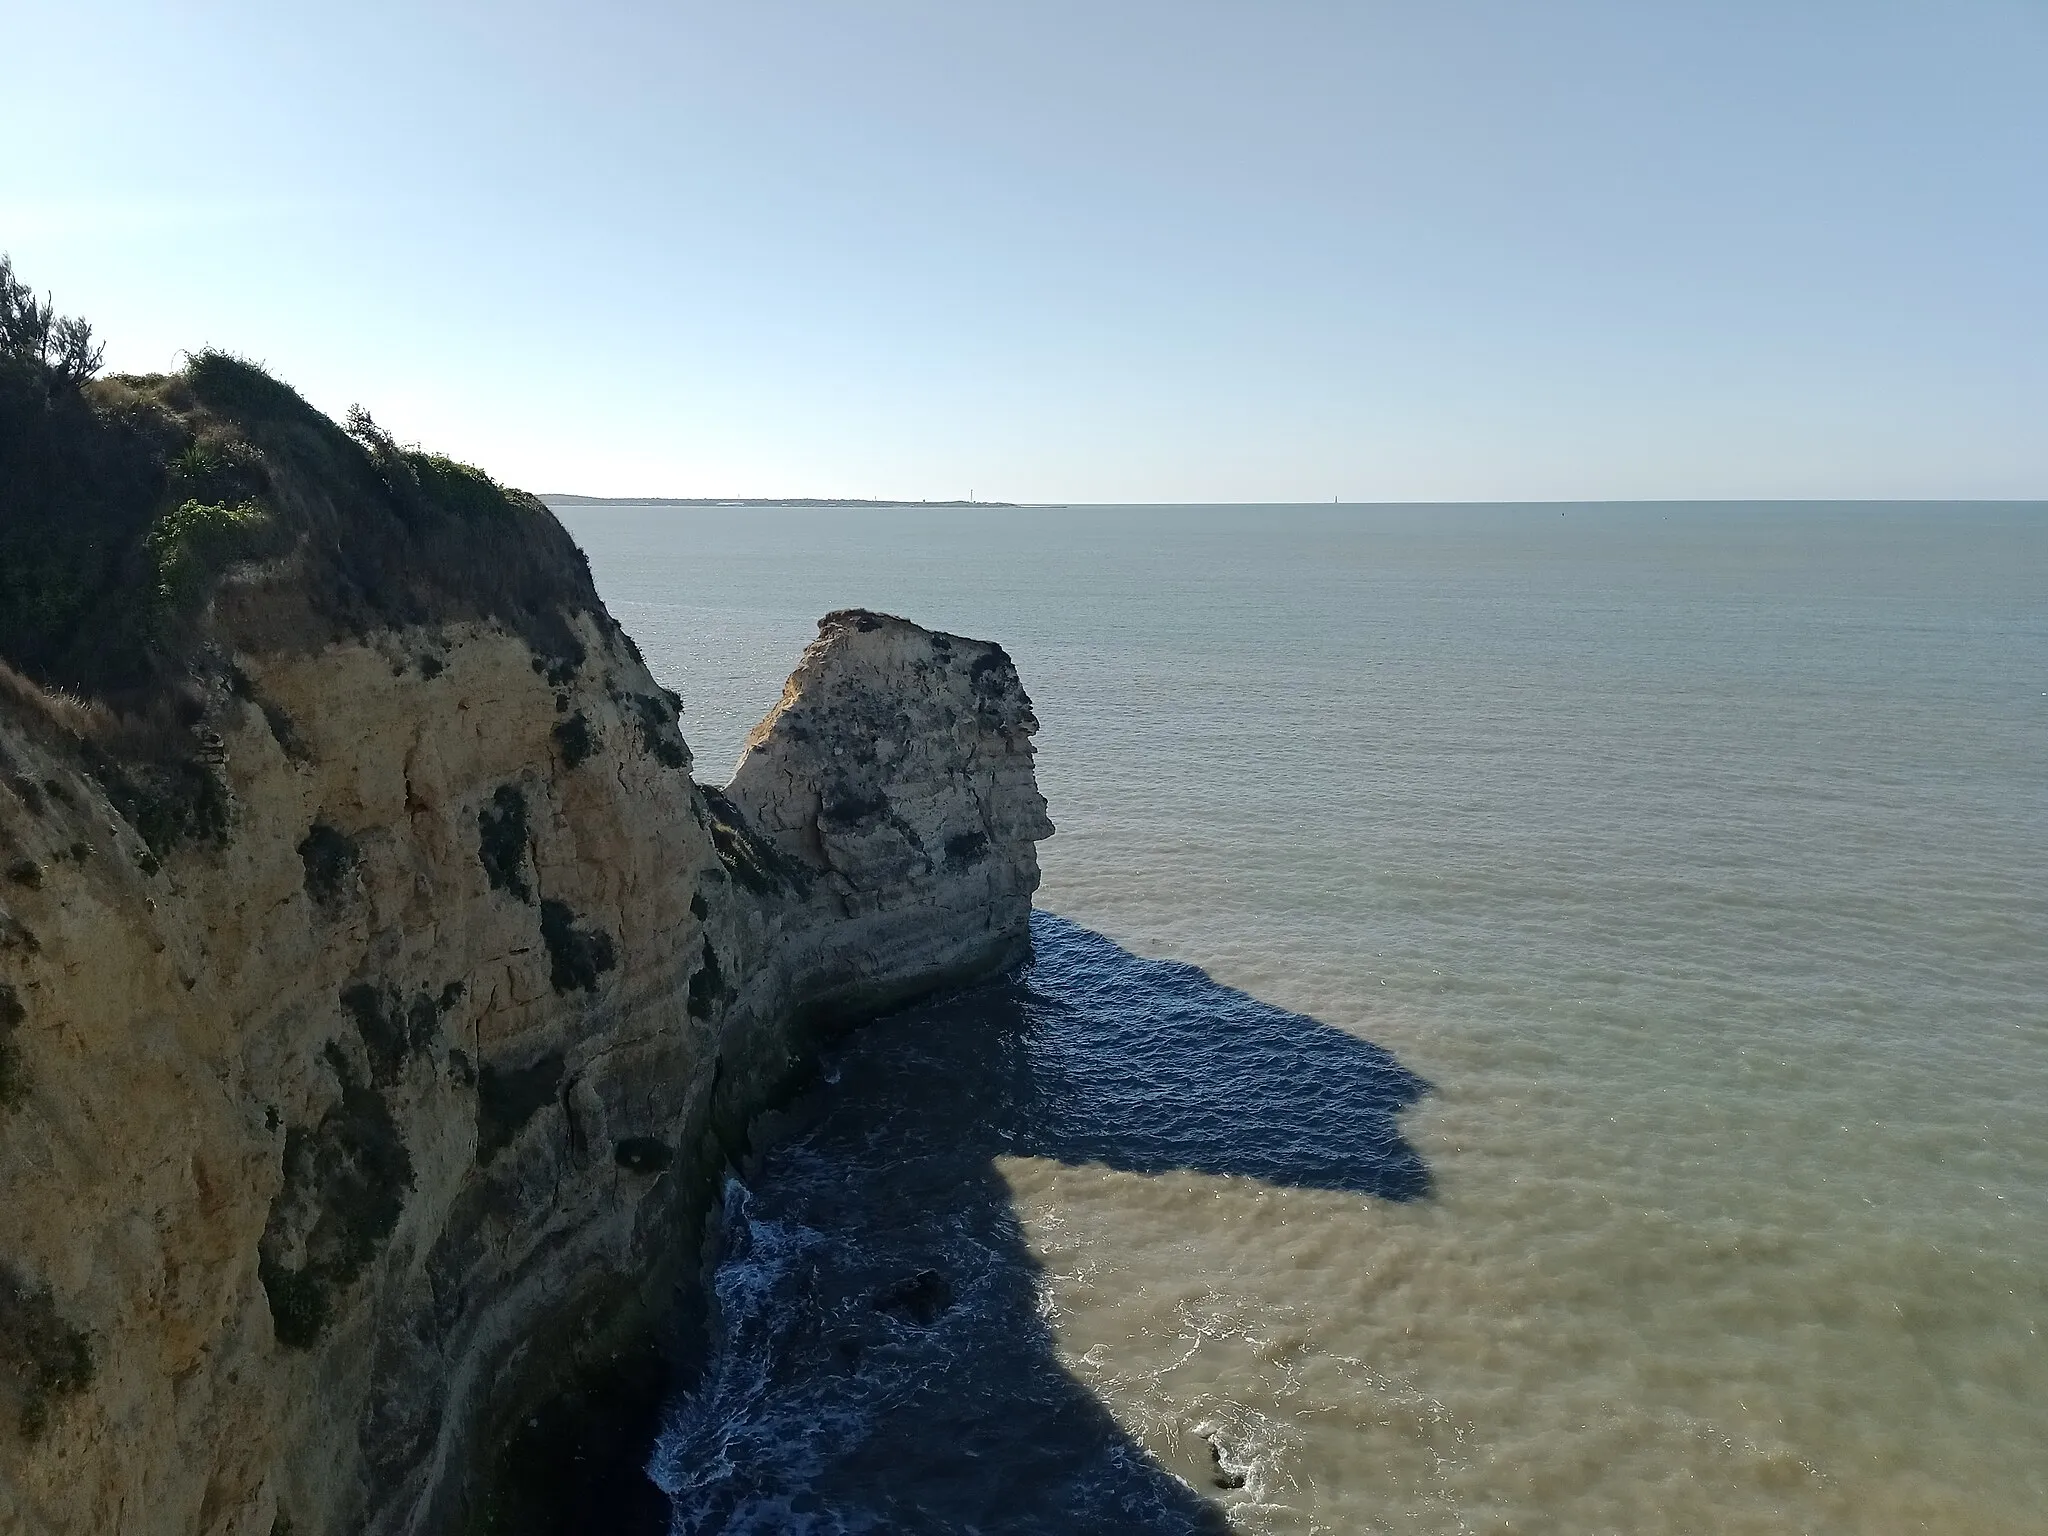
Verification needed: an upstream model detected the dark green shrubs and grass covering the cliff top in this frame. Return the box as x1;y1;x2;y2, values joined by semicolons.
0;256;602;708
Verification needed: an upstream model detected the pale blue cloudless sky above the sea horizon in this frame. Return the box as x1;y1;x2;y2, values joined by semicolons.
0;0;2048;502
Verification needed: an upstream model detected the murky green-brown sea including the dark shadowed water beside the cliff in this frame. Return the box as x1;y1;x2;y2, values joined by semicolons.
563;504;2048;1536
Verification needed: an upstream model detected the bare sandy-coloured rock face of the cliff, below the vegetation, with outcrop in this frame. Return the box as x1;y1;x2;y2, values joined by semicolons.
0;612;1051;1536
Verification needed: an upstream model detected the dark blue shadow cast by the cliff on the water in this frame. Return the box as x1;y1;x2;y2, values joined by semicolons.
649;911;1430;1536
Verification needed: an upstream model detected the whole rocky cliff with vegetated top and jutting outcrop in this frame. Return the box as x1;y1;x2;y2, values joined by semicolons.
0;354;1051;1536
